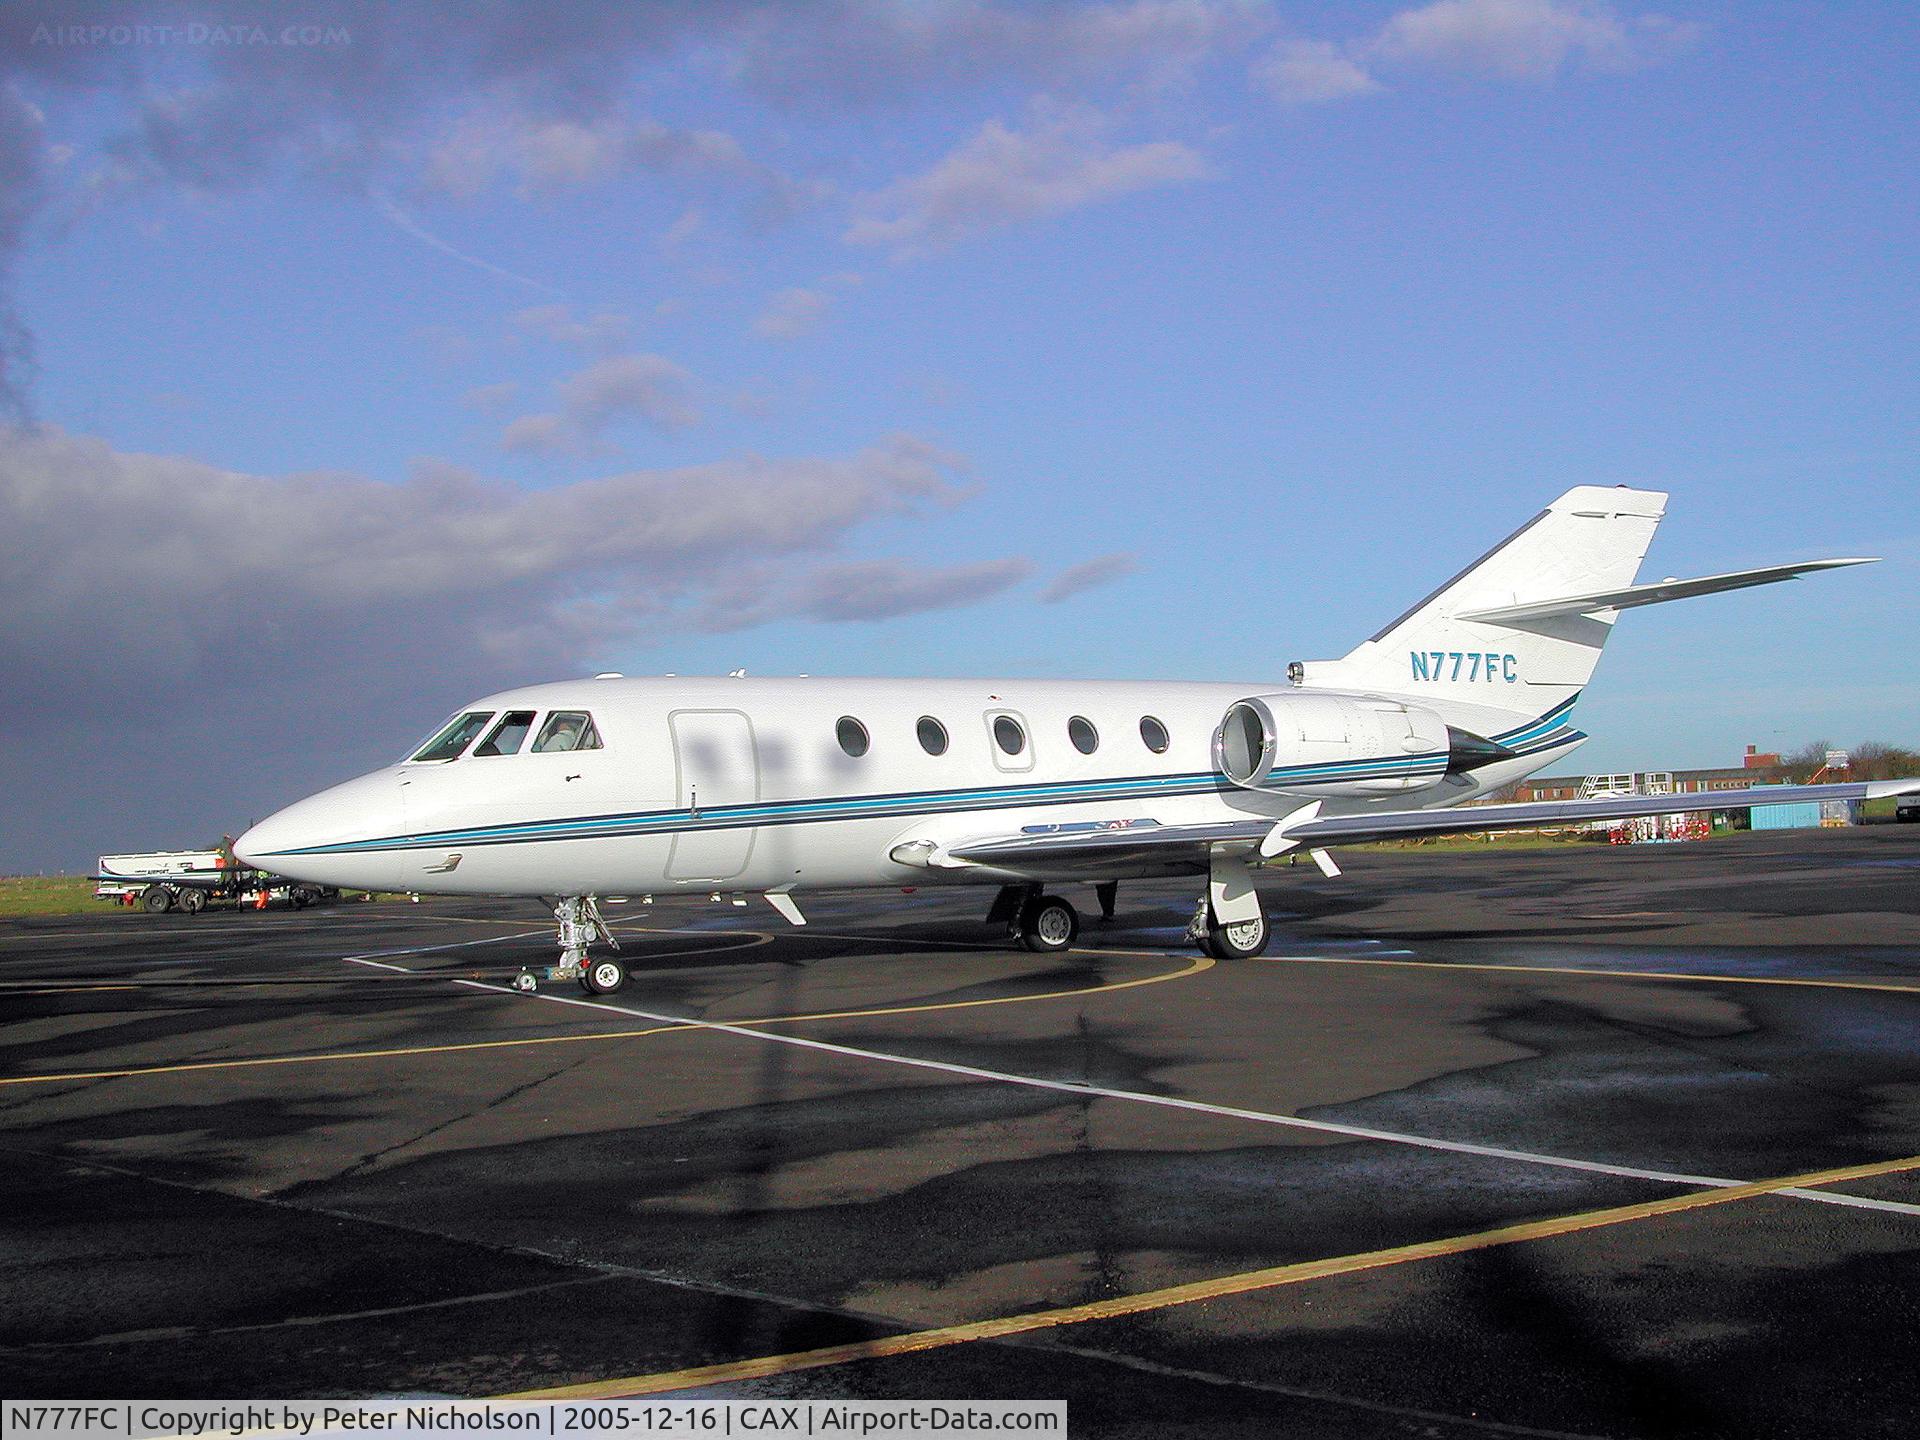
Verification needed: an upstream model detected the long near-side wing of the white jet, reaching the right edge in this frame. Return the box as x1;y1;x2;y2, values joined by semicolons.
917;780;1920;877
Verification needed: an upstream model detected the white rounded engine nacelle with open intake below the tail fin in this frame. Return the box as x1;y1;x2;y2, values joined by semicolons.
1213;689;1451;795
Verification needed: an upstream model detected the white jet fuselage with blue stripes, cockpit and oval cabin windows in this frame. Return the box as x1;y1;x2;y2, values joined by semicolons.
236;676;1584;897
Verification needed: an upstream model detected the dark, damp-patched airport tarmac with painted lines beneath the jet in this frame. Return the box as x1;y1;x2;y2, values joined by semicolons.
0;826;1920;1436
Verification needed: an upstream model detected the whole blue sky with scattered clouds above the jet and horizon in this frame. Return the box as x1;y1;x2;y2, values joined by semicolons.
0;0;1920;870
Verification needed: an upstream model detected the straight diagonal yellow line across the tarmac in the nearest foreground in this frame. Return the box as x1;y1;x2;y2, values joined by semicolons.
493;1156;1920;1400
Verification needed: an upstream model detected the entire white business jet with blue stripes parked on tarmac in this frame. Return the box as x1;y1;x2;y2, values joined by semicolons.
234;486;1920;995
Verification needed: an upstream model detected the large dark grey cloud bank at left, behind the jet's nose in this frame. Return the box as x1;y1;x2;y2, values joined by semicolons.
0;426;990;868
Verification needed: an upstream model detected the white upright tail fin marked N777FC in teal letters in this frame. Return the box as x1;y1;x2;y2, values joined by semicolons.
1302;486;1667;716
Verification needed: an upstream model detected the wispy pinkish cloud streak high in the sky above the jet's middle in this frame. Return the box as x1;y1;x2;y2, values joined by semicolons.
847;109;1208;259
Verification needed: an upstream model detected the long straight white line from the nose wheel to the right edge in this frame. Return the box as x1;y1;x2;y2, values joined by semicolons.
453;979;1920;1213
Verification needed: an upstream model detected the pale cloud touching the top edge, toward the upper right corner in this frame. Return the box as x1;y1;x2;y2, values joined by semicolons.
1371;0;1697;81
